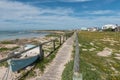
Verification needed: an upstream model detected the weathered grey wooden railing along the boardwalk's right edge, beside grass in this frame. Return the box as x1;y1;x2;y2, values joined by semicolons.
73;32;82;80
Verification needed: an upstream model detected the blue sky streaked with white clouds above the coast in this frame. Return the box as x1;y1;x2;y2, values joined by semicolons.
0;0;120;30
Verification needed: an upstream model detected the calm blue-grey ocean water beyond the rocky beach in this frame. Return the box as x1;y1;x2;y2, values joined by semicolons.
0;31;49;41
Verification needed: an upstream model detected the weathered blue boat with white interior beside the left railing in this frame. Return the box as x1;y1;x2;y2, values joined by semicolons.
8;45;39;72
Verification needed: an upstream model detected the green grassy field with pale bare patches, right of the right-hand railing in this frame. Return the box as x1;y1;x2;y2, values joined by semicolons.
78;31;120;80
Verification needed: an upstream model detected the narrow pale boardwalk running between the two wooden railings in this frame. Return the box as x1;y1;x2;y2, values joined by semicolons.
37;35;74;80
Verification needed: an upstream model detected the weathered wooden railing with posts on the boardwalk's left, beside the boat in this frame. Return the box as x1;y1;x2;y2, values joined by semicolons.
0;33;73;63
